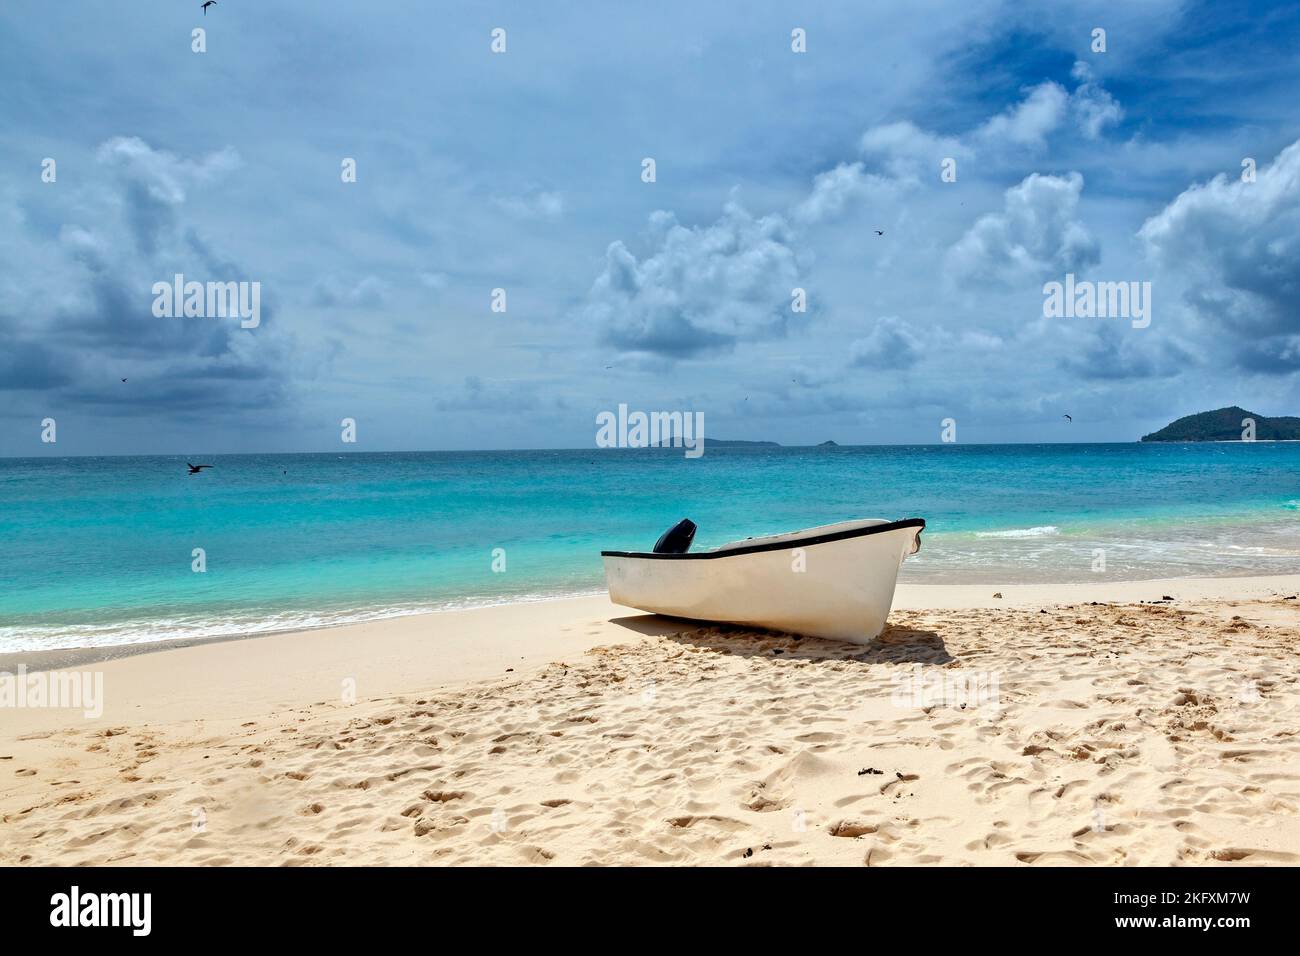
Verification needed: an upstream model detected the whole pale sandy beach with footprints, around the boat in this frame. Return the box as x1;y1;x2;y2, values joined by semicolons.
0;576;1300;866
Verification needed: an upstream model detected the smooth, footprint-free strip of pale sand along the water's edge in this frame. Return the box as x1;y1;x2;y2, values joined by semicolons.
0;575;1300;741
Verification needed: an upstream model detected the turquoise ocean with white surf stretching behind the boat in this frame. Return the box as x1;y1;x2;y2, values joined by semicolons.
0;442;1300;652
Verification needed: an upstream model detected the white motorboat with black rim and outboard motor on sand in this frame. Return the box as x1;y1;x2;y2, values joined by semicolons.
601;518;926;644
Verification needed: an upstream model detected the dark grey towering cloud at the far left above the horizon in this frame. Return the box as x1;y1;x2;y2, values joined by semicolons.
0;138;287;416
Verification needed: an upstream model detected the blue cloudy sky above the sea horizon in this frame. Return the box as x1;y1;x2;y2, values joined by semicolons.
0;0;1300;455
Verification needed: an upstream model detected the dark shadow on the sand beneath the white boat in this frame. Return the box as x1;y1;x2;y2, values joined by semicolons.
611;614;956;665
